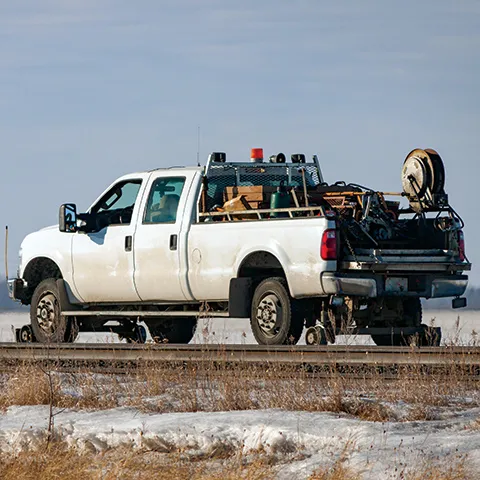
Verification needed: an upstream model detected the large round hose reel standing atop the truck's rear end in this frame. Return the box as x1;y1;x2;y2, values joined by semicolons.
402;148;448;212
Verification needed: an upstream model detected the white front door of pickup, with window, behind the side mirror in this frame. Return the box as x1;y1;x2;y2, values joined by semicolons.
72;174;145;303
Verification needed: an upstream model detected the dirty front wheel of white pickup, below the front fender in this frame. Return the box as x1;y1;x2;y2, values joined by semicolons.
30;278;77;343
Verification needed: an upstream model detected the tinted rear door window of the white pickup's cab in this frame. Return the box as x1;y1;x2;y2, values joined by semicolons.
143;177;185;223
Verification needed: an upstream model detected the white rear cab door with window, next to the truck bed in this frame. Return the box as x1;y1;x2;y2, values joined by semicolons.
134;170;197;302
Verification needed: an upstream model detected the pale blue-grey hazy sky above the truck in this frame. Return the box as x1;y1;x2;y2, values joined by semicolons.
0;0;480;285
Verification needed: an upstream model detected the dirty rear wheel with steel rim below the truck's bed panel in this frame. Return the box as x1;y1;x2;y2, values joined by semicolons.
250;277;304;345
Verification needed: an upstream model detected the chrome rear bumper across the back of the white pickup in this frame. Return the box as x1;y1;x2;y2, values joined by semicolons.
320;272;468;298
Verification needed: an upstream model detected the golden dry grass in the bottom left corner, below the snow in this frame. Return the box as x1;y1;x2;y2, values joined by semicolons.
0;443;275;480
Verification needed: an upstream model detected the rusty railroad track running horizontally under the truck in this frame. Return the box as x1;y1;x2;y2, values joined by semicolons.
0;343;480;377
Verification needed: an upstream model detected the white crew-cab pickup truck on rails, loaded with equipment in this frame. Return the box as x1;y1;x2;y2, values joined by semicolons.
9;150;471;345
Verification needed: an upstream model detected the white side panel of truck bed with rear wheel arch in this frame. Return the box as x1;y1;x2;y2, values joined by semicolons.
188;217;336;300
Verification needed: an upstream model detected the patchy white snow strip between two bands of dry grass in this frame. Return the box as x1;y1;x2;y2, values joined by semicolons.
0;406;480;479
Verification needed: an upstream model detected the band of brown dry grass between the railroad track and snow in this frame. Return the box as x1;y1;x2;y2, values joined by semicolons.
0;348;480;422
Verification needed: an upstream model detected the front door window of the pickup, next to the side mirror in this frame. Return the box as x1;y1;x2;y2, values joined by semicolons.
91;179;142;226
